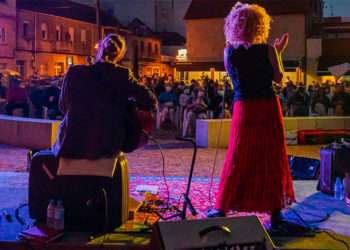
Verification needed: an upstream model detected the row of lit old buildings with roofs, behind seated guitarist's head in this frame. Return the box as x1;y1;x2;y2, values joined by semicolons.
0;0;172;79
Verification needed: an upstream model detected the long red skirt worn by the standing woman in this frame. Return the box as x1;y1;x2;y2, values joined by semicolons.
215;97;295;212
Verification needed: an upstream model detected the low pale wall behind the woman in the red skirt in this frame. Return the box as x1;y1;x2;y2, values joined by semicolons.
196;116;350;148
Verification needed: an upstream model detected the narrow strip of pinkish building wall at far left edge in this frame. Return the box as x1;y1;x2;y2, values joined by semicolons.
0;0;16;70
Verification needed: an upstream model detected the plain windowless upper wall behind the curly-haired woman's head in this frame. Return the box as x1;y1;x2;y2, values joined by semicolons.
186;15;306;61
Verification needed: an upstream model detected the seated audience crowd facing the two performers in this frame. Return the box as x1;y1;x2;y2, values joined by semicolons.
0;70;350;136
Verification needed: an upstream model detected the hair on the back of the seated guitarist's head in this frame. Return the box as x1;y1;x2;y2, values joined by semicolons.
96;33;126;63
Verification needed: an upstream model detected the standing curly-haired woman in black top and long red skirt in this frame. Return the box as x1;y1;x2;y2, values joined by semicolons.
208;2;295;225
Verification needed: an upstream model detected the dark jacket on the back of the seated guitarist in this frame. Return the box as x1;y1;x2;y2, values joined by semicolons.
52;62;156;159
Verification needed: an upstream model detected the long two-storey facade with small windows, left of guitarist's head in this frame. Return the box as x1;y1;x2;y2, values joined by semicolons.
16;9;98;78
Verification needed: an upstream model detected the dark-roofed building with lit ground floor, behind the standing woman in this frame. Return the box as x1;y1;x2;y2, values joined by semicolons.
176;0;322;84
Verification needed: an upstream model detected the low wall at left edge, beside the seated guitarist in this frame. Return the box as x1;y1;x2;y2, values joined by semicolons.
0;115;60;148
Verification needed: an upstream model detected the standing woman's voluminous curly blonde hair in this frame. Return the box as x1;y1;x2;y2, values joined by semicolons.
224;2;271;47
